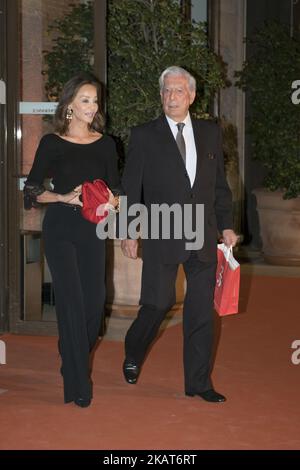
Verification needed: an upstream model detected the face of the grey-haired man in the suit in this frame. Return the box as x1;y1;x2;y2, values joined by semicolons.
160;75;196;122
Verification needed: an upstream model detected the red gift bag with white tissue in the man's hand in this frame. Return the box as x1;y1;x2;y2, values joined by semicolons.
214;243;240;316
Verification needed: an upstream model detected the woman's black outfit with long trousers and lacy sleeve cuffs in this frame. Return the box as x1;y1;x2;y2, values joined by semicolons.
24;134;119;402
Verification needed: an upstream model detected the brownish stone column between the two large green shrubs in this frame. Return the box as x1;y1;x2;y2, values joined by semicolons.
209;0;247;232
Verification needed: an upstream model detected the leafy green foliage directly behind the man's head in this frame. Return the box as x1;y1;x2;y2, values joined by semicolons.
107;0;225;157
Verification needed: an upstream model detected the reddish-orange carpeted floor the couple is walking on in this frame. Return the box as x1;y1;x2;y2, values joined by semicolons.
0;276;300;450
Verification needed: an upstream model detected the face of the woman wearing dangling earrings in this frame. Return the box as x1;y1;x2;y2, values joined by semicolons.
68;84;98;124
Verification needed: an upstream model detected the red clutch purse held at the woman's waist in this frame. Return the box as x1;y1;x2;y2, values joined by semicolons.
81;179;109;224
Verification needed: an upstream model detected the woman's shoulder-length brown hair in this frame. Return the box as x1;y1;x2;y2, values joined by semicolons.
54;72;104;135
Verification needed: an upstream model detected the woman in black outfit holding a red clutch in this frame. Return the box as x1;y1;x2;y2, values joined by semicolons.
24;74;119;407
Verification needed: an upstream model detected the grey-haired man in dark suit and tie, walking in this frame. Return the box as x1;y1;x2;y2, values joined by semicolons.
122;66;237;403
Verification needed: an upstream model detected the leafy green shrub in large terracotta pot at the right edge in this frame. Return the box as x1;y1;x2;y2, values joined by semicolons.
236;22;300;265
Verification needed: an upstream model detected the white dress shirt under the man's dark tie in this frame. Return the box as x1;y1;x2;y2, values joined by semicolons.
166;113;197;186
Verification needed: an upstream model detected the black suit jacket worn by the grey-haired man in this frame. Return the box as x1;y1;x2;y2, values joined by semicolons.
122;115;232;263
